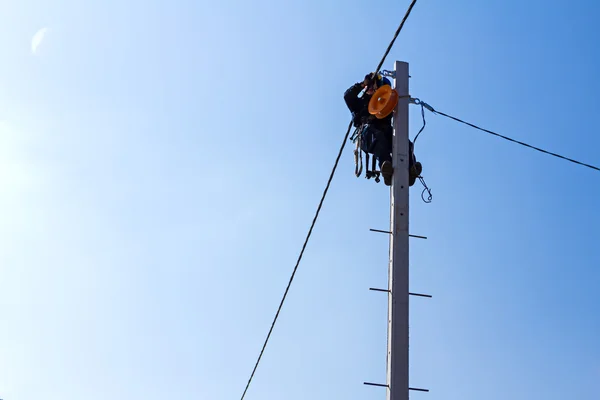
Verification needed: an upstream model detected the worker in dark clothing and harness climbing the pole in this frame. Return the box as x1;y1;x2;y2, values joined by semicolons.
344;73;422;186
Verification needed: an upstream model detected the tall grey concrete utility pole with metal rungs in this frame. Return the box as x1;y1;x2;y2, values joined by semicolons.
387;61;409;400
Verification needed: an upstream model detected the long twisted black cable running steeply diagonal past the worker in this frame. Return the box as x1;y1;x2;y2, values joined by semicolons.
241;0;417;400
